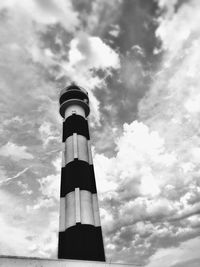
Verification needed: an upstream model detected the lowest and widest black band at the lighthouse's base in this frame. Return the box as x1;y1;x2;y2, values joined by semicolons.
58;224;105;261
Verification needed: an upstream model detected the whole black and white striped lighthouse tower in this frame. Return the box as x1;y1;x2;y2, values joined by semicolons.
58;84;105;261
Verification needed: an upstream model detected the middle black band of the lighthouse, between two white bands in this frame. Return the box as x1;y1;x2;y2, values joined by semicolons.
60;160;97;197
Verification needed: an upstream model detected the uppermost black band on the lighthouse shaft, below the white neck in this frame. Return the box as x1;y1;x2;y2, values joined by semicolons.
63;114;90;142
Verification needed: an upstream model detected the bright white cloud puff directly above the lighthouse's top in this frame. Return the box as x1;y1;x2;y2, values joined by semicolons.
59;32;120;90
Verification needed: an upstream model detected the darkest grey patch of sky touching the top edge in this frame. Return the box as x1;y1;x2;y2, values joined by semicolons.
108;0;158;55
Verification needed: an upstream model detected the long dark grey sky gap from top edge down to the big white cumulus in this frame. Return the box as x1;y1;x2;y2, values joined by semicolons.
89;1;160;153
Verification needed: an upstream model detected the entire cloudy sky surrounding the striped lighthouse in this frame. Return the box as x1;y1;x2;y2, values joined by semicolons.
0;0;200;267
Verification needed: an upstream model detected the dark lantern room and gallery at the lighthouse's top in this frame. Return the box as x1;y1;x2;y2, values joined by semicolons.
59;83;90;118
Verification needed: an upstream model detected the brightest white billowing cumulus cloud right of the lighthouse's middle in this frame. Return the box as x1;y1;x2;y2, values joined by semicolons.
95;121;176;196
